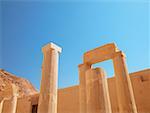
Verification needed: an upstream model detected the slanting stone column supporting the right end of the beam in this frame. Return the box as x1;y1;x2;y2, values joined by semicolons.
113;52;137;113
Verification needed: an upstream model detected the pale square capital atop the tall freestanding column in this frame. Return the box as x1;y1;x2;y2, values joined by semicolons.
42;42;62;53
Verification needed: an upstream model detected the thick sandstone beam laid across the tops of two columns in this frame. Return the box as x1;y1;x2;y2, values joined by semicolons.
83;43;119;64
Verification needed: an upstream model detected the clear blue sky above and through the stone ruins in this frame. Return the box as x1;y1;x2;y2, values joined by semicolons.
0;0;150;89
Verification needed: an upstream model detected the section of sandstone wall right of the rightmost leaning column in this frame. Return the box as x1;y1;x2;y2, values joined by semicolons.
131;69;150;113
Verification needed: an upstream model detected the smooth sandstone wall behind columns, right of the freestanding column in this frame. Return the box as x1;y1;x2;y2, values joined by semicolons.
58;69;150;113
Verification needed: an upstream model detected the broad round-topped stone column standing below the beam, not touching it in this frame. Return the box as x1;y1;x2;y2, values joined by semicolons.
86;68;112;113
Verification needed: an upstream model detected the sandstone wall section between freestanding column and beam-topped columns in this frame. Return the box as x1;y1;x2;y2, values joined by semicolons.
58;86;79;113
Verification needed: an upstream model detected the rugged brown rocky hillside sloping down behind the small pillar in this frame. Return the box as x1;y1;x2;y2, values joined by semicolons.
0;69;37;97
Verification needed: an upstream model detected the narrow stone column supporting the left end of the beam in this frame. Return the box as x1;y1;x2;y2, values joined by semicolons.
78;64;91;113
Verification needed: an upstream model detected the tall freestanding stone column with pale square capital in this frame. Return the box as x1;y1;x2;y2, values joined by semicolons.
38;43;61;113
